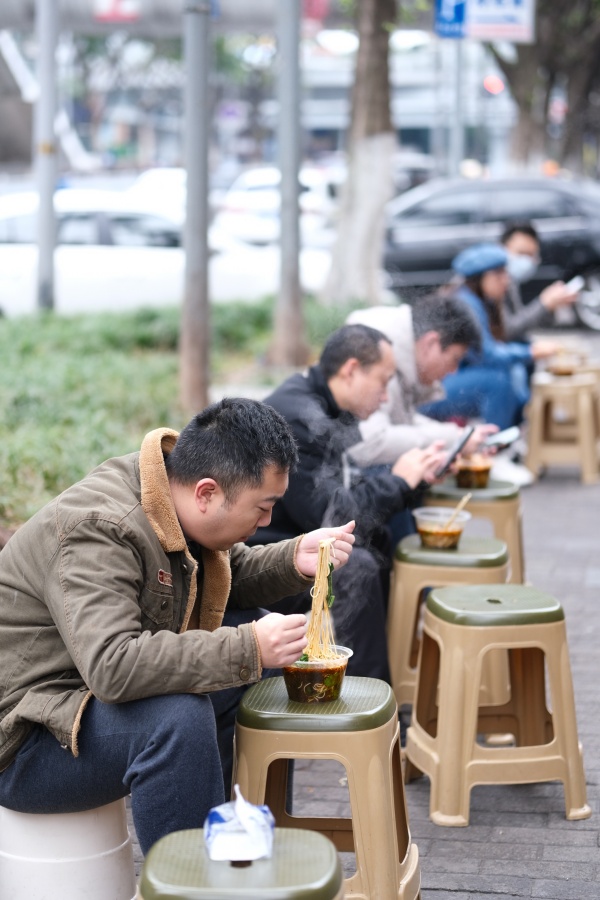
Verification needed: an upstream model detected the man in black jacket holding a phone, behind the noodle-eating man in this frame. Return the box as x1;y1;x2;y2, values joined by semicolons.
251;325;443;680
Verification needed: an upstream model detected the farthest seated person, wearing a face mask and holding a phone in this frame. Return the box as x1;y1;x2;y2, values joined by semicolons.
500;222;578;341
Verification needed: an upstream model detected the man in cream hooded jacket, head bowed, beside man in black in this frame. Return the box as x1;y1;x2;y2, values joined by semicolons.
346;297;498;466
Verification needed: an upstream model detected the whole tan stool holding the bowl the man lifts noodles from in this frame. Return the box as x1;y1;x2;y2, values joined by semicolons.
234;675;421;900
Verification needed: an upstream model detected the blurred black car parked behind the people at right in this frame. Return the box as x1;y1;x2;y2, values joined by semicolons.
383;178;600;330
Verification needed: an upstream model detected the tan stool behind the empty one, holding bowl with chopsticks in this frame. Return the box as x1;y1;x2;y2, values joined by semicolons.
387;534;509;706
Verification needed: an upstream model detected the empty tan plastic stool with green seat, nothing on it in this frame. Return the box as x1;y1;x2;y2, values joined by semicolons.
406;584;591;825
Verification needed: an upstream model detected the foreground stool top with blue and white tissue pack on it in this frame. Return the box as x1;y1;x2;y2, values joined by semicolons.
138;828;344;900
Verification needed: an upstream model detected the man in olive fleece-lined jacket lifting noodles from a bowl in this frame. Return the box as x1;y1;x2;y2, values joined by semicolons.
0;400;354;854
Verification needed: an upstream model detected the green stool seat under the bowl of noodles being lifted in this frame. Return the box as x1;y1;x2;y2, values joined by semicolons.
237;676;396;731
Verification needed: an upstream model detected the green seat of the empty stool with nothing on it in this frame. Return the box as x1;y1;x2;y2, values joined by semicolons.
427;584;565;628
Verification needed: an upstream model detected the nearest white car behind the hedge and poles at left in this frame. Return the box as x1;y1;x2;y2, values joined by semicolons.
0;189;329;316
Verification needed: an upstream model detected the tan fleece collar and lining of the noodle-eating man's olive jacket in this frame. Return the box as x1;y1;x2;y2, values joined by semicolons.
140;428;231;631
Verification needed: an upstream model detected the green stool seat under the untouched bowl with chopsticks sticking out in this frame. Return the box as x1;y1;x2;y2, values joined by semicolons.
396;534;508;569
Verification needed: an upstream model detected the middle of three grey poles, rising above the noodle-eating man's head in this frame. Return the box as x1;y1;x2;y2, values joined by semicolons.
180;0;211;413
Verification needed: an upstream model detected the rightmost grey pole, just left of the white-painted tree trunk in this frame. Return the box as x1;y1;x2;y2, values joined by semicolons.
270;0;308;366
